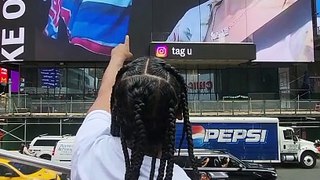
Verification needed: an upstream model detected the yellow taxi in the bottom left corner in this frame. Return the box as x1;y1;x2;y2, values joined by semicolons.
0;158;60;180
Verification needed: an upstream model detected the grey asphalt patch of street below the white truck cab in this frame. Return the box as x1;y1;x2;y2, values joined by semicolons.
277;159;320;180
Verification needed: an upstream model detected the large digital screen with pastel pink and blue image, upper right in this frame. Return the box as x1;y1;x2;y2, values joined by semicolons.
153;0;314;62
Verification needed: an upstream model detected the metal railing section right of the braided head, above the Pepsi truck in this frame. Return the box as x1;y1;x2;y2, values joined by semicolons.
189;99;320;116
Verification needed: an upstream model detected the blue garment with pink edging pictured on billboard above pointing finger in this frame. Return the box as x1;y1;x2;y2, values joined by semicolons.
44;0;132;55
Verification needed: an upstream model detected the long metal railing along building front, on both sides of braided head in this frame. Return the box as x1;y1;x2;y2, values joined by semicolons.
0;96;320;116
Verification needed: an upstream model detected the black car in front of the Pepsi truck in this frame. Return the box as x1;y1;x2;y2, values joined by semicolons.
175;149;277;180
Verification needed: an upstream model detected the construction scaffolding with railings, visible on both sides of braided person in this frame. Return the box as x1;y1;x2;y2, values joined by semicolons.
0;94;320;149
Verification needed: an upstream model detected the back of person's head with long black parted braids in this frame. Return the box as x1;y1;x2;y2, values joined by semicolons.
111;57;199;179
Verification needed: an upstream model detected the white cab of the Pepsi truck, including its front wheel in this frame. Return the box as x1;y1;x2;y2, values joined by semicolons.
279;126;320;168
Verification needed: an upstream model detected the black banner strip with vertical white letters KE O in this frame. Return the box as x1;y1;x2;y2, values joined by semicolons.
0;0;36;62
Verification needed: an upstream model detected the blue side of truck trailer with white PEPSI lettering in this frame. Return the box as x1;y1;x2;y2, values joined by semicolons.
176;123;279;160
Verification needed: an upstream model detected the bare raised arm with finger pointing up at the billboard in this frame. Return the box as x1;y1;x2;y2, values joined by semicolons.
88;36;132;113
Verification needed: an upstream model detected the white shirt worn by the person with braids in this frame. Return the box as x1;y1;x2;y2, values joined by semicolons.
71;110;190;180
